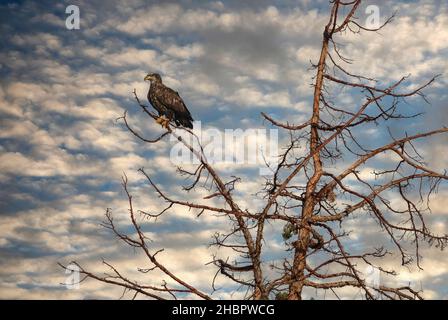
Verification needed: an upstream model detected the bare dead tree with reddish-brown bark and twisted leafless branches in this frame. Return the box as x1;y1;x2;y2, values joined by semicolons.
60;0;448;300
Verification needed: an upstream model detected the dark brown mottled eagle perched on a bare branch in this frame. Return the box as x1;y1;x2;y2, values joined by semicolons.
145;73;193;129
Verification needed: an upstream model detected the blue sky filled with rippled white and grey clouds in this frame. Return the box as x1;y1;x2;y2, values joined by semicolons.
0;0;448;299
